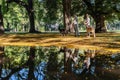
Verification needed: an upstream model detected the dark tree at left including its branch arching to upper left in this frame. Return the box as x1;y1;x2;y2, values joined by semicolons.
7;0;37;33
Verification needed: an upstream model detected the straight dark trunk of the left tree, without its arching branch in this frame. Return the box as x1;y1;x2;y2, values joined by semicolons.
28;0;36;33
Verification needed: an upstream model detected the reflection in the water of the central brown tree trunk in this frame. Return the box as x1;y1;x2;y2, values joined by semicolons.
61;47;77;80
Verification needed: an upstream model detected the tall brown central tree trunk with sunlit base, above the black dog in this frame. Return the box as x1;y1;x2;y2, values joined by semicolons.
63;0;71;30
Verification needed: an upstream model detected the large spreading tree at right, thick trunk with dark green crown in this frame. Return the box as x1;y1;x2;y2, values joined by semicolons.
82;0;120;32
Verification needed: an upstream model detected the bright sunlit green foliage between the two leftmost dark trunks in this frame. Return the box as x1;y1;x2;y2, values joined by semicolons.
4;3;28;29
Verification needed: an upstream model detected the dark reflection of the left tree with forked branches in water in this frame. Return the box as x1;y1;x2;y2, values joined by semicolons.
2;47;35;80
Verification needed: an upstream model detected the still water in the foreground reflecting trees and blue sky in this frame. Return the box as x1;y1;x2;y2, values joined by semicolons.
0;46;120;80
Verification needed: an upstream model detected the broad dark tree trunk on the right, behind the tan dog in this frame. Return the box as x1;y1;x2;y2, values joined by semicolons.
94;14;107;33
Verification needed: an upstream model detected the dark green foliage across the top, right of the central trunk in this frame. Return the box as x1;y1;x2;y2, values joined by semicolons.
71;0;120;20
